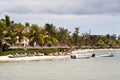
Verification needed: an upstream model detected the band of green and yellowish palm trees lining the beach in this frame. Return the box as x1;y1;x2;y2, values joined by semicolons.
0;15;120;54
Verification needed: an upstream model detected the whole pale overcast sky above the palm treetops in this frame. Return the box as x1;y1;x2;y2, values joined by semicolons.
0;0;120;35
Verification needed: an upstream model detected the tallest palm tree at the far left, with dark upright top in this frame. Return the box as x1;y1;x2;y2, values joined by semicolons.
0;15;14;51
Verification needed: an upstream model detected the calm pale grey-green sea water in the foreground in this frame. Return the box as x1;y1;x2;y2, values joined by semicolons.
0;50;120;80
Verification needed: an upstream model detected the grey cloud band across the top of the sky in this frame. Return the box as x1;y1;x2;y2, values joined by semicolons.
0;0;120;15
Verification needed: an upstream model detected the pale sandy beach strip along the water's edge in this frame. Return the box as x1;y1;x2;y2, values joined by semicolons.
0;49;120;62
